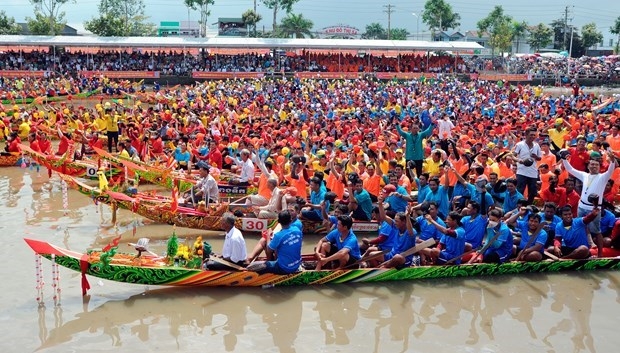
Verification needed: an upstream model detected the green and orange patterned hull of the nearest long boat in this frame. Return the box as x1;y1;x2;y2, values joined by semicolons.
25;239;620;288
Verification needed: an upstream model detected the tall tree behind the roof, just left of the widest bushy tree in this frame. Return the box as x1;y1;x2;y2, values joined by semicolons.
26;0;75;36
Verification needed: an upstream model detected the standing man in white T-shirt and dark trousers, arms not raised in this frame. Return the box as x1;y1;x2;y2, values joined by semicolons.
512;128;542;205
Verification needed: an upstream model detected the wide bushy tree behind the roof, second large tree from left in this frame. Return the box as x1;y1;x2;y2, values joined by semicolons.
84;0;155;37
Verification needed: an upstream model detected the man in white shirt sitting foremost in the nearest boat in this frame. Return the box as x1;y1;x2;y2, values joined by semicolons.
204;212;248;271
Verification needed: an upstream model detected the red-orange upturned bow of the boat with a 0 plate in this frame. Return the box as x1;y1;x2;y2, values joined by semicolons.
20;144;122;179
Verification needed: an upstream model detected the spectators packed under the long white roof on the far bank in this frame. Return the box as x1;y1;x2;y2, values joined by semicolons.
0;51;469;76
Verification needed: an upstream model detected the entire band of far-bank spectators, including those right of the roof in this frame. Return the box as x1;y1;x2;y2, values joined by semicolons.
0;50;620;82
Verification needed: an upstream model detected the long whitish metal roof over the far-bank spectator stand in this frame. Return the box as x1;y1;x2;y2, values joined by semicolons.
0;35;484;52
